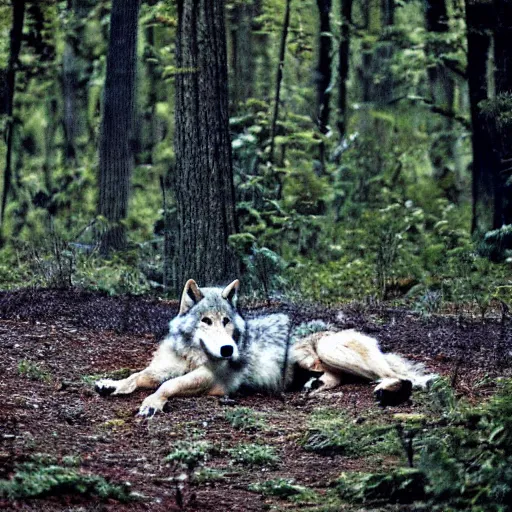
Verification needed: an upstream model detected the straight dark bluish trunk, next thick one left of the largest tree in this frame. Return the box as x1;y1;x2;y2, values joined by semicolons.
98;0;139;254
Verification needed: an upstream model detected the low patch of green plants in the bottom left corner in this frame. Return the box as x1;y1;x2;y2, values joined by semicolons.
0;462;132;502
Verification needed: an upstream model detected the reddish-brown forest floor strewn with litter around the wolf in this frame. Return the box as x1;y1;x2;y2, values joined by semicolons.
0;290;512;512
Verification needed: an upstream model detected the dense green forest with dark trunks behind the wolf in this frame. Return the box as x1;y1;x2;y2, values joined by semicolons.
0;0;512;316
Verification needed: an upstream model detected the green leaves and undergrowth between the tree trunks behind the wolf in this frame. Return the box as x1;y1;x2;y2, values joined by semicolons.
0;0;504;317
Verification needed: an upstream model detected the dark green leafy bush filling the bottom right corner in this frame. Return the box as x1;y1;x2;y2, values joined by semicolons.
419;381;512;512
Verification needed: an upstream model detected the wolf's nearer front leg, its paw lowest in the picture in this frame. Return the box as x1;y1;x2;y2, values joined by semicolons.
139;366;219;418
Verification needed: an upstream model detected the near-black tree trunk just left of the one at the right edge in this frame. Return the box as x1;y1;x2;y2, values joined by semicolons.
466;0;498;235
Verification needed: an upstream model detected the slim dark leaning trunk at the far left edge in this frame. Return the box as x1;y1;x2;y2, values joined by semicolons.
0;0;25;241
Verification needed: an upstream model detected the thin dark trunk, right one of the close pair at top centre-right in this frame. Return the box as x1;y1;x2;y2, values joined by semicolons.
336;0;353;140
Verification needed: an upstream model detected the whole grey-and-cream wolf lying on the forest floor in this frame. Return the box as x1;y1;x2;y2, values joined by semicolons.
95;279;431;417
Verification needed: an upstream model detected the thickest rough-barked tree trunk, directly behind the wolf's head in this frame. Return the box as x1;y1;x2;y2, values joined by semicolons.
173;0;238;291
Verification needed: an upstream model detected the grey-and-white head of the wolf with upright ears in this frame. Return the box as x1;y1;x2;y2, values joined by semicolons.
171;279;245;361
